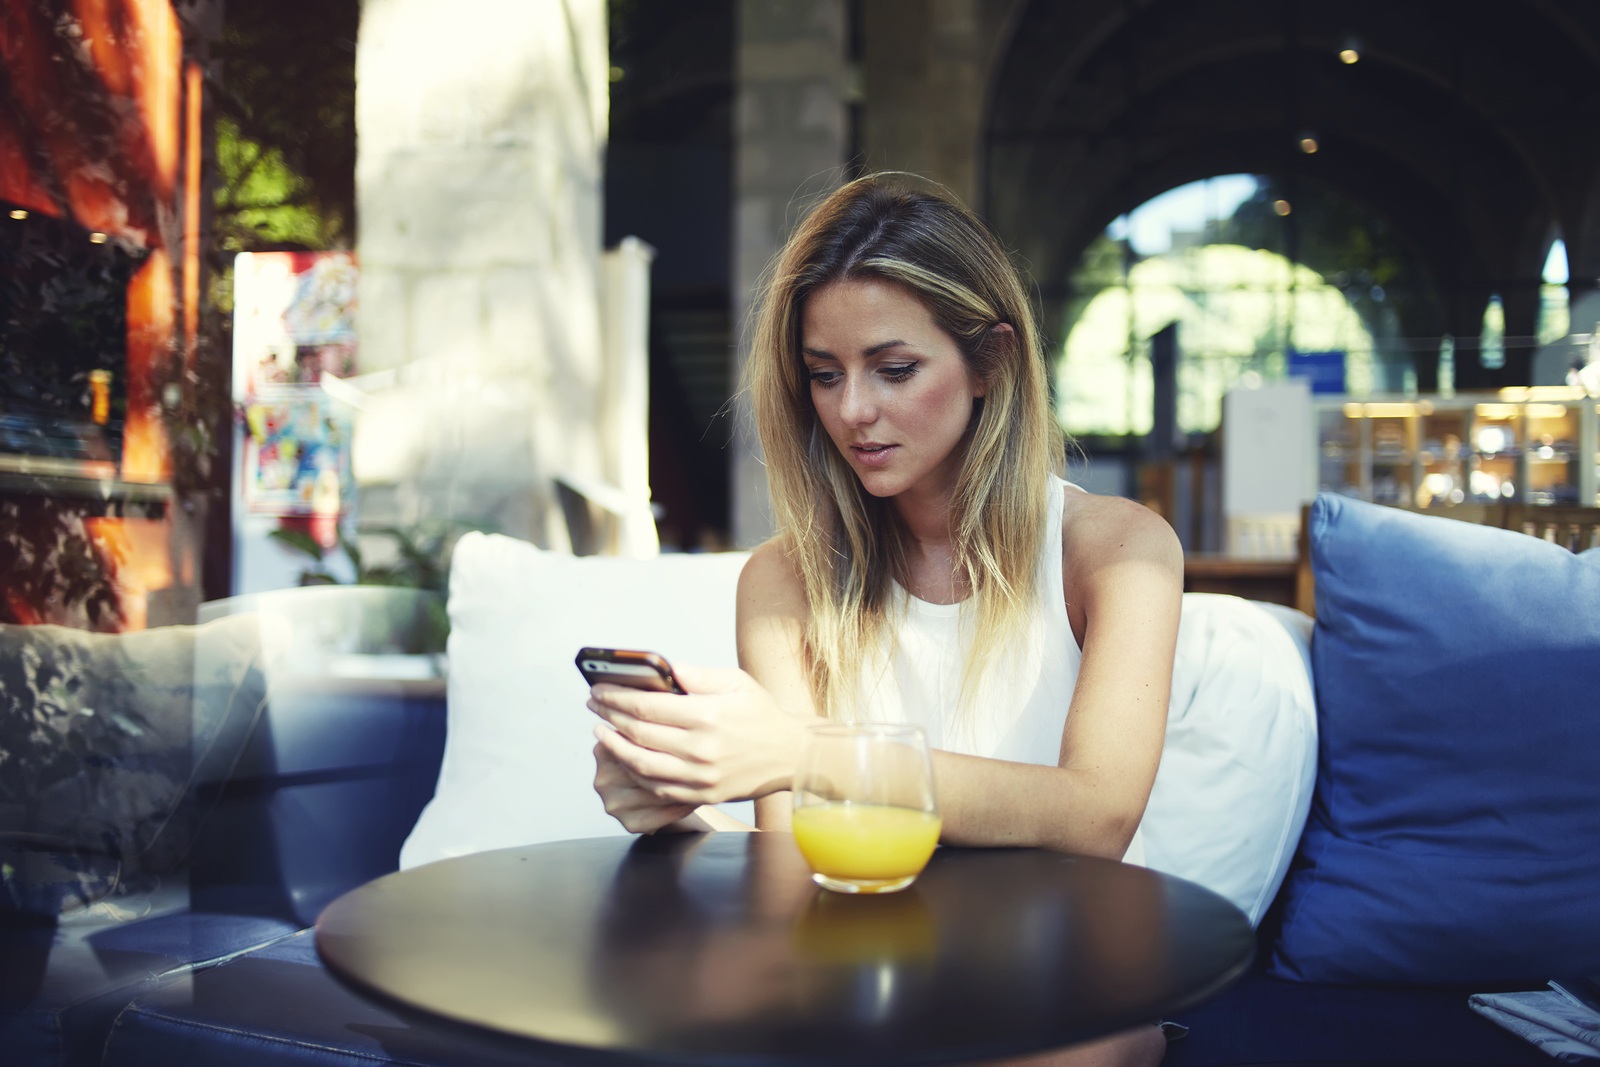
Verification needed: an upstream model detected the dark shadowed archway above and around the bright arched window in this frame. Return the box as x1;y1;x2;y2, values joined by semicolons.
982;0;1600;387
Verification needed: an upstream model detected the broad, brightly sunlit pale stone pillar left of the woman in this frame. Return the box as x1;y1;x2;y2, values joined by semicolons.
355;0;608;547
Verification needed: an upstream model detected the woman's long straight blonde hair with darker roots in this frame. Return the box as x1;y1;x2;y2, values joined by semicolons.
746;174;1064;718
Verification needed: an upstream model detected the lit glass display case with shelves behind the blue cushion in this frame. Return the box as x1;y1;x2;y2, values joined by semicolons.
1314;387;1600;507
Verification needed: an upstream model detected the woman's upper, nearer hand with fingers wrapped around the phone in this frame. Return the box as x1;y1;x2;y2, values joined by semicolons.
589;664;821;805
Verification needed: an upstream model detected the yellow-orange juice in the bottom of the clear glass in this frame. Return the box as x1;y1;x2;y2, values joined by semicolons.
792;803;939;885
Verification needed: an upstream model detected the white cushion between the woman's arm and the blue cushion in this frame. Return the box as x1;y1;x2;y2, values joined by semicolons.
1139;593;1317;925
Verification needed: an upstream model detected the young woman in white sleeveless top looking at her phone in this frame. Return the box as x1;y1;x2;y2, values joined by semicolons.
590;176;1182;1064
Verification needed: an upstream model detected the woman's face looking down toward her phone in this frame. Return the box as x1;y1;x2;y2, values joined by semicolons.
800;278;984;498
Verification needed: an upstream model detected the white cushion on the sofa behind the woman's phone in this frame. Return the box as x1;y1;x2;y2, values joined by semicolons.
400;533;750;869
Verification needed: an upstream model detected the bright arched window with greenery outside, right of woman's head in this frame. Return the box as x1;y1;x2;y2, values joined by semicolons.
1056;174;1397;437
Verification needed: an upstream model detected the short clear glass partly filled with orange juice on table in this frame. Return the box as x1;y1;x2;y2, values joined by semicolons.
794;723;939;893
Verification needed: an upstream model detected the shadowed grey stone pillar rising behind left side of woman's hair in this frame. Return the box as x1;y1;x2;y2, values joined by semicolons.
731;0;850;547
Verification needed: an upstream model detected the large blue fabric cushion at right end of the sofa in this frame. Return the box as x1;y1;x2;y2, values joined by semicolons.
1270;494;1600;985
